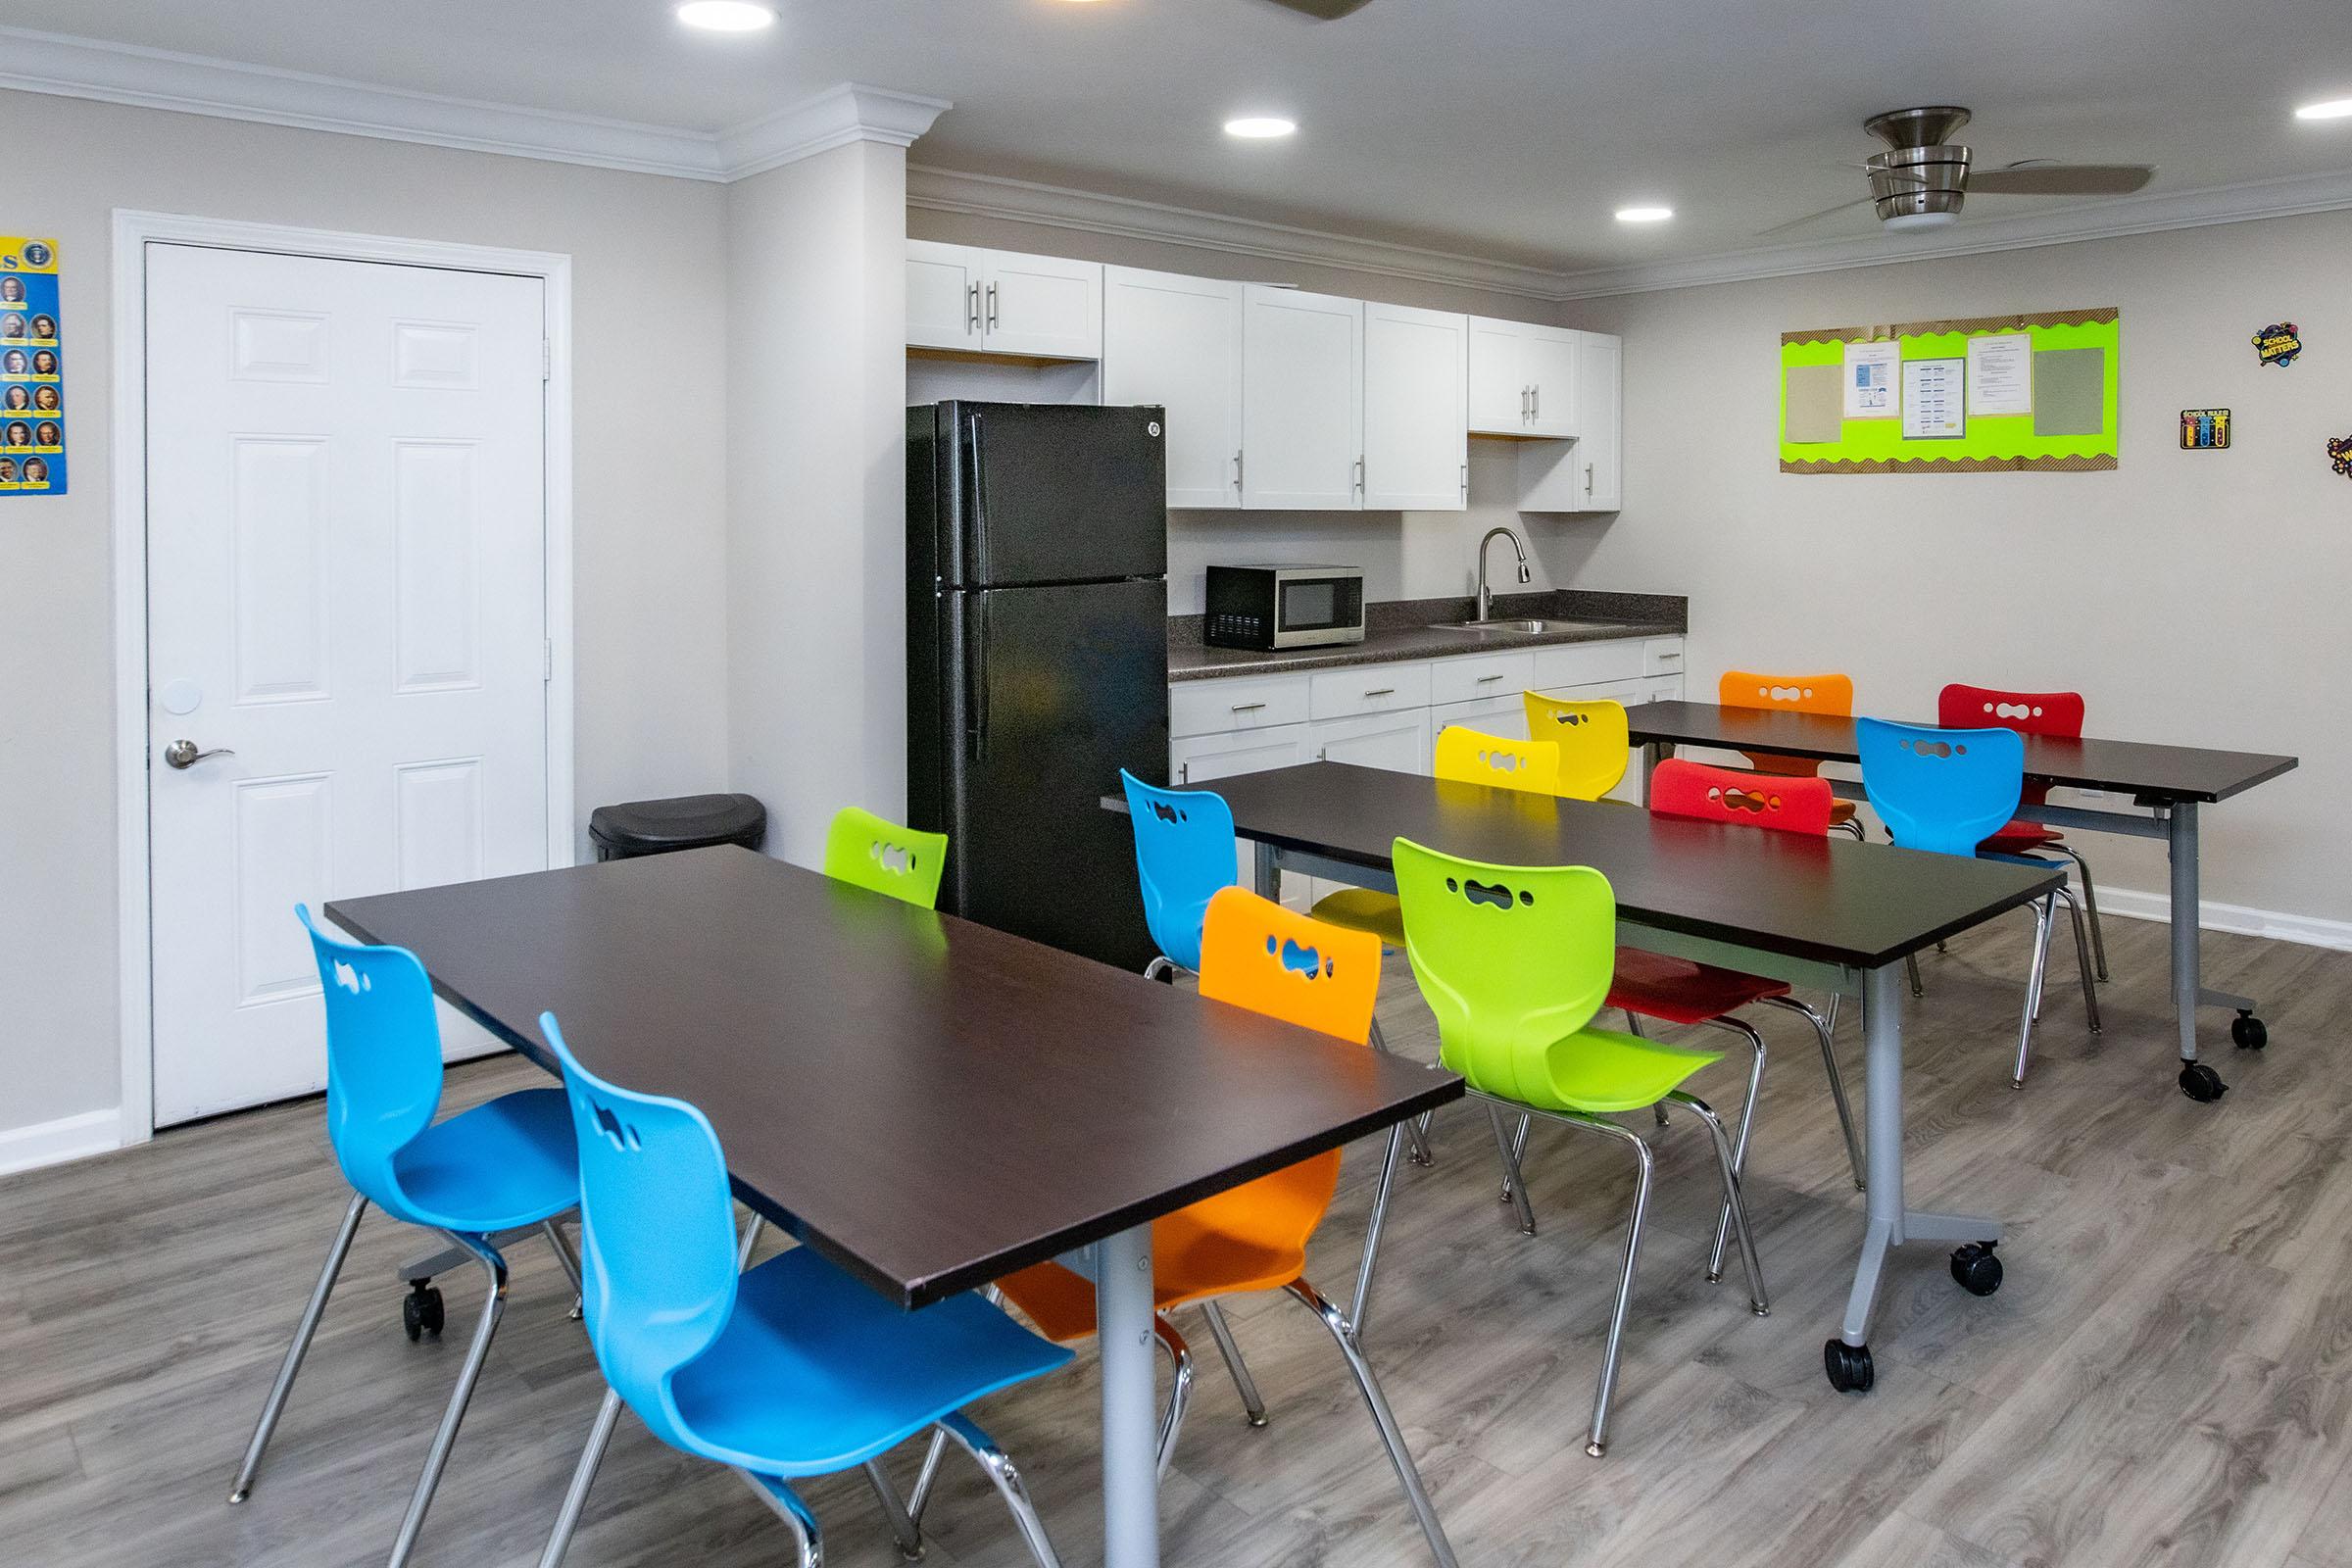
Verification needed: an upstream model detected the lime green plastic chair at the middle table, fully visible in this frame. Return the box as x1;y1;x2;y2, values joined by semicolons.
1390;839;1771;1457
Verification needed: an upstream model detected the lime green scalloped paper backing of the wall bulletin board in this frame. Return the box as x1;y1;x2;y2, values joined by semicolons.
1781;308;2122;472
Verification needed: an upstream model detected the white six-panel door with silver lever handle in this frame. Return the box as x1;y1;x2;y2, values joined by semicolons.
146;244;548;1126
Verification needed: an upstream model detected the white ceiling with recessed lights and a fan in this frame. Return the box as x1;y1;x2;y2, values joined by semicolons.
14;0;2352;270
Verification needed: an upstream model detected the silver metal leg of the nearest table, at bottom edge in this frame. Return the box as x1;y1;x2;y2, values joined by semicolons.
1094;1225;1159;1568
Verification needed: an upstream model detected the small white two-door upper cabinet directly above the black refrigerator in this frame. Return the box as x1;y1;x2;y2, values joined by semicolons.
906;240;1103;360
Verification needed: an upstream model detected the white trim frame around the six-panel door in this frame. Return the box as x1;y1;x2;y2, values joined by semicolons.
108;207;578;1145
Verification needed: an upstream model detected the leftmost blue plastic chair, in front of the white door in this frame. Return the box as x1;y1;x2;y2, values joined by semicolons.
228;906;578;1568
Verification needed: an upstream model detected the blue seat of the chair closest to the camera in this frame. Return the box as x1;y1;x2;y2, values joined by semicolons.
670;1246;1070;1479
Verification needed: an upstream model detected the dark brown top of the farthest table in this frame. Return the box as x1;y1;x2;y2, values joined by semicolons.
1625;703;2295;802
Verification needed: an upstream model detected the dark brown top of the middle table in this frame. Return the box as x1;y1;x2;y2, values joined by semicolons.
1216;761;2065;968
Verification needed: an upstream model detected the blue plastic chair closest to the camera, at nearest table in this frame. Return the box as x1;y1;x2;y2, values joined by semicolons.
539;1013;1070;1568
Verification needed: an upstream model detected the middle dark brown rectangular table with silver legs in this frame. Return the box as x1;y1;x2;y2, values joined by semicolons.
1216;761;2065;1392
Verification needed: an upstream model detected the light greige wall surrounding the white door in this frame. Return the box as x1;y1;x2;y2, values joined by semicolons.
0;92;727;1147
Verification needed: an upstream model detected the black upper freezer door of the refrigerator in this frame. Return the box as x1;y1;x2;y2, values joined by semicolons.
934;402;1169;588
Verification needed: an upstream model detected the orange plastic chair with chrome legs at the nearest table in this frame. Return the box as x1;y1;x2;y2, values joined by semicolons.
978;886;1453;1568
